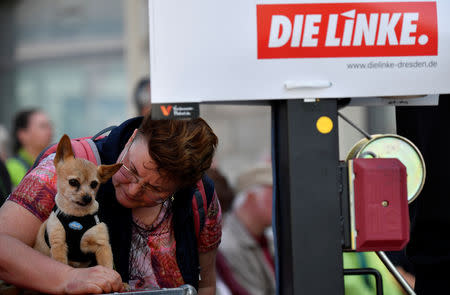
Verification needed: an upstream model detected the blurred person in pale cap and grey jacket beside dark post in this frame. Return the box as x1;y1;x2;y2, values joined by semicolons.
218;164;275;294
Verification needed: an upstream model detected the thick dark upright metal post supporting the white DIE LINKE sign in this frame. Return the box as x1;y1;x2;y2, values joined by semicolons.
272;99;344;295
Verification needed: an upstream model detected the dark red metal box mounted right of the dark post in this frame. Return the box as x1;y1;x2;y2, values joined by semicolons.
349;158;409;251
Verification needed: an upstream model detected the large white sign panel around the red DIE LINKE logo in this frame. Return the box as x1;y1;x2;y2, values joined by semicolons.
149;0;450;103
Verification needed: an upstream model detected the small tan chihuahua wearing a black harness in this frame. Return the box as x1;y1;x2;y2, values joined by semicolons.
34;134;122;269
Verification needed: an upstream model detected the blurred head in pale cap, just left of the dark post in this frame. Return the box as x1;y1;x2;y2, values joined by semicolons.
233;163;273;236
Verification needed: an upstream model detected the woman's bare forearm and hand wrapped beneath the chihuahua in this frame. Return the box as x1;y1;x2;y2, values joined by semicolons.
0;232;124;294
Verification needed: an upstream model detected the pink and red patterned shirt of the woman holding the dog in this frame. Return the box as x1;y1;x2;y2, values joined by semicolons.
9;154;222;290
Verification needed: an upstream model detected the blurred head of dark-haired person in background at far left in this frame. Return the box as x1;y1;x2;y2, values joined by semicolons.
13;108;53;158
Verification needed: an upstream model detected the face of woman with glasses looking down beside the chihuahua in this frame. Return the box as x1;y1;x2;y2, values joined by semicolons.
112;135;177;208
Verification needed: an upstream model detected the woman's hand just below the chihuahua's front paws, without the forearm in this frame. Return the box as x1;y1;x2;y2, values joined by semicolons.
62;266;124;294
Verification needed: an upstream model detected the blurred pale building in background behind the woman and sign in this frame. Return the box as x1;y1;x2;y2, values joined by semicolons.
0;0;392;184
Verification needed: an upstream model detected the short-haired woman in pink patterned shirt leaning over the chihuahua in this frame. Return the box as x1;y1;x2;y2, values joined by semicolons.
0;116;221;294
